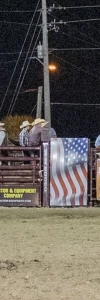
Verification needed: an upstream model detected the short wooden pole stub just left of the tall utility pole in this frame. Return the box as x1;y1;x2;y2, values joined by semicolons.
36;86;43;118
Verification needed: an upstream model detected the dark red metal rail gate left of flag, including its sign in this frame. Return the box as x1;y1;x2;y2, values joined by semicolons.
0;146;41;207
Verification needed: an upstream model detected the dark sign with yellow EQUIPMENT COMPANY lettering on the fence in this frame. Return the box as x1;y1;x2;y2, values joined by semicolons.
0;185;40;206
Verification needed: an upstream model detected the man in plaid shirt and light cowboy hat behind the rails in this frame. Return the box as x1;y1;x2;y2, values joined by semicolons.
19;121;31;164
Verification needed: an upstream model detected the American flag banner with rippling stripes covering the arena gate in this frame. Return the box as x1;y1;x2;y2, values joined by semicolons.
50;138;88;207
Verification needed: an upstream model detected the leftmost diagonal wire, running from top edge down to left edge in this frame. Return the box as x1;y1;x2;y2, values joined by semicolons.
0;0;40;112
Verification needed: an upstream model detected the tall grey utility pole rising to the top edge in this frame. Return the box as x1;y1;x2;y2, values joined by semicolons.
42;0;51;126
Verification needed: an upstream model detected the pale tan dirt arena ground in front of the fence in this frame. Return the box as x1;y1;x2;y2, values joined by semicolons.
0;208;100;300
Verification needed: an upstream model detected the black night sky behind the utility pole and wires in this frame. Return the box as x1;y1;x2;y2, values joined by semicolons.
0;0;100;139
